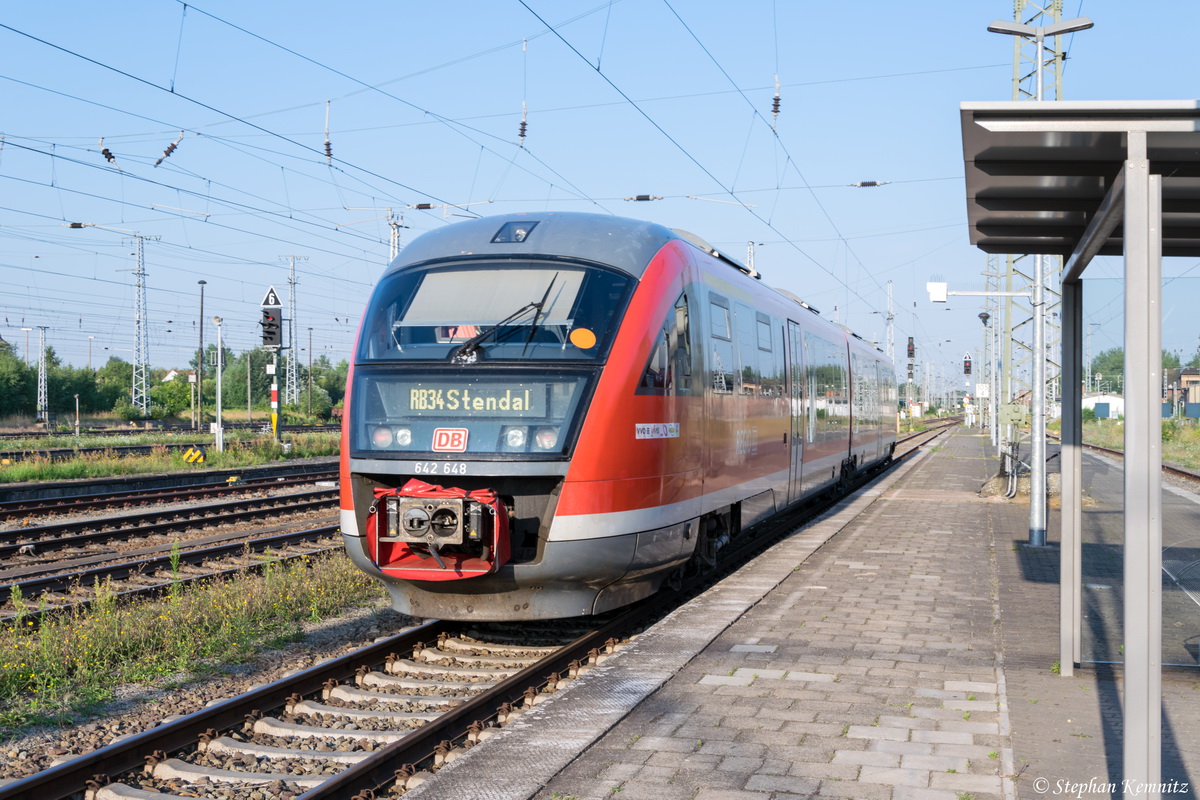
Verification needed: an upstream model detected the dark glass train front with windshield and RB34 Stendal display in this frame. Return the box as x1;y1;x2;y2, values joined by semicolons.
350;261;634;458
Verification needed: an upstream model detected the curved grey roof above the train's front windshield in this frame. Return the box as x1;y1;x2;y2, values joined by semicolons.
391;211;757;278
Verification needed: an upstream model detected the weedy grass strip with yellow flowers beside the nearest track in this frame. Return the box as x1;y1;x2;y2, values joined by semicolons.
0;552;383;735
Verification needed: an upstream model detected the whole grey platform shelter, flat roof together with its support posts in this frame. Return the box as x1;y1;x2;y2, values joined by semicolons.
961;101;1200;800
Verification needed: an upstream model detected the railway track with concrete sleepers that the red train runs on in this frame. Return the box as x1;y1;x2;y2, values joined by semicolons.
0;425;952;800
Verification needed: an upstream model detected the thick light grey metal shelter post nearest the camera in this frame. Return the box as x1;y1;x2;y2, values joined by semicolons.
1123;131;1163;800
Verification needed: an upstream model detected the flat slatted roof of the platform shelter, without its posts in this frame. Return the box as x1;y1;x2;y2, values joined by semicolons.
961;100;1200;255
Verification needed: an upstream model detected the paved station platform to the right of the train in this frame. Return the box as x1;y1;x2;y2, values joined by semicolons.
407;429;1200;800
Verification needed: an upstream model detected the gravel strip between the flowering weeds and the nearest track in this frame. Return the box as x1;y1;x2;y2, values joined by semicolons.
0;600;418;780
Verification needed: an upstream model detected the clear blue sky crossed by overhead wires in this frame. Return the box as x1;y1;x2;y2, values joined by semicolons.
0;0;1200;388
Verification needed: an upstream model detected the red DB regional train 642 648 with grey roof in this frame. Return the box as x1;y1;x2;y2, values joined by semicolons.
341;212;896;620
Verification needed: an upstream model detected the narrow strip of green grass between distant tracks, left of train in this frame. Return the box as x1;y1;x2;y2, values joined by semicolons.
0;432;341;483
